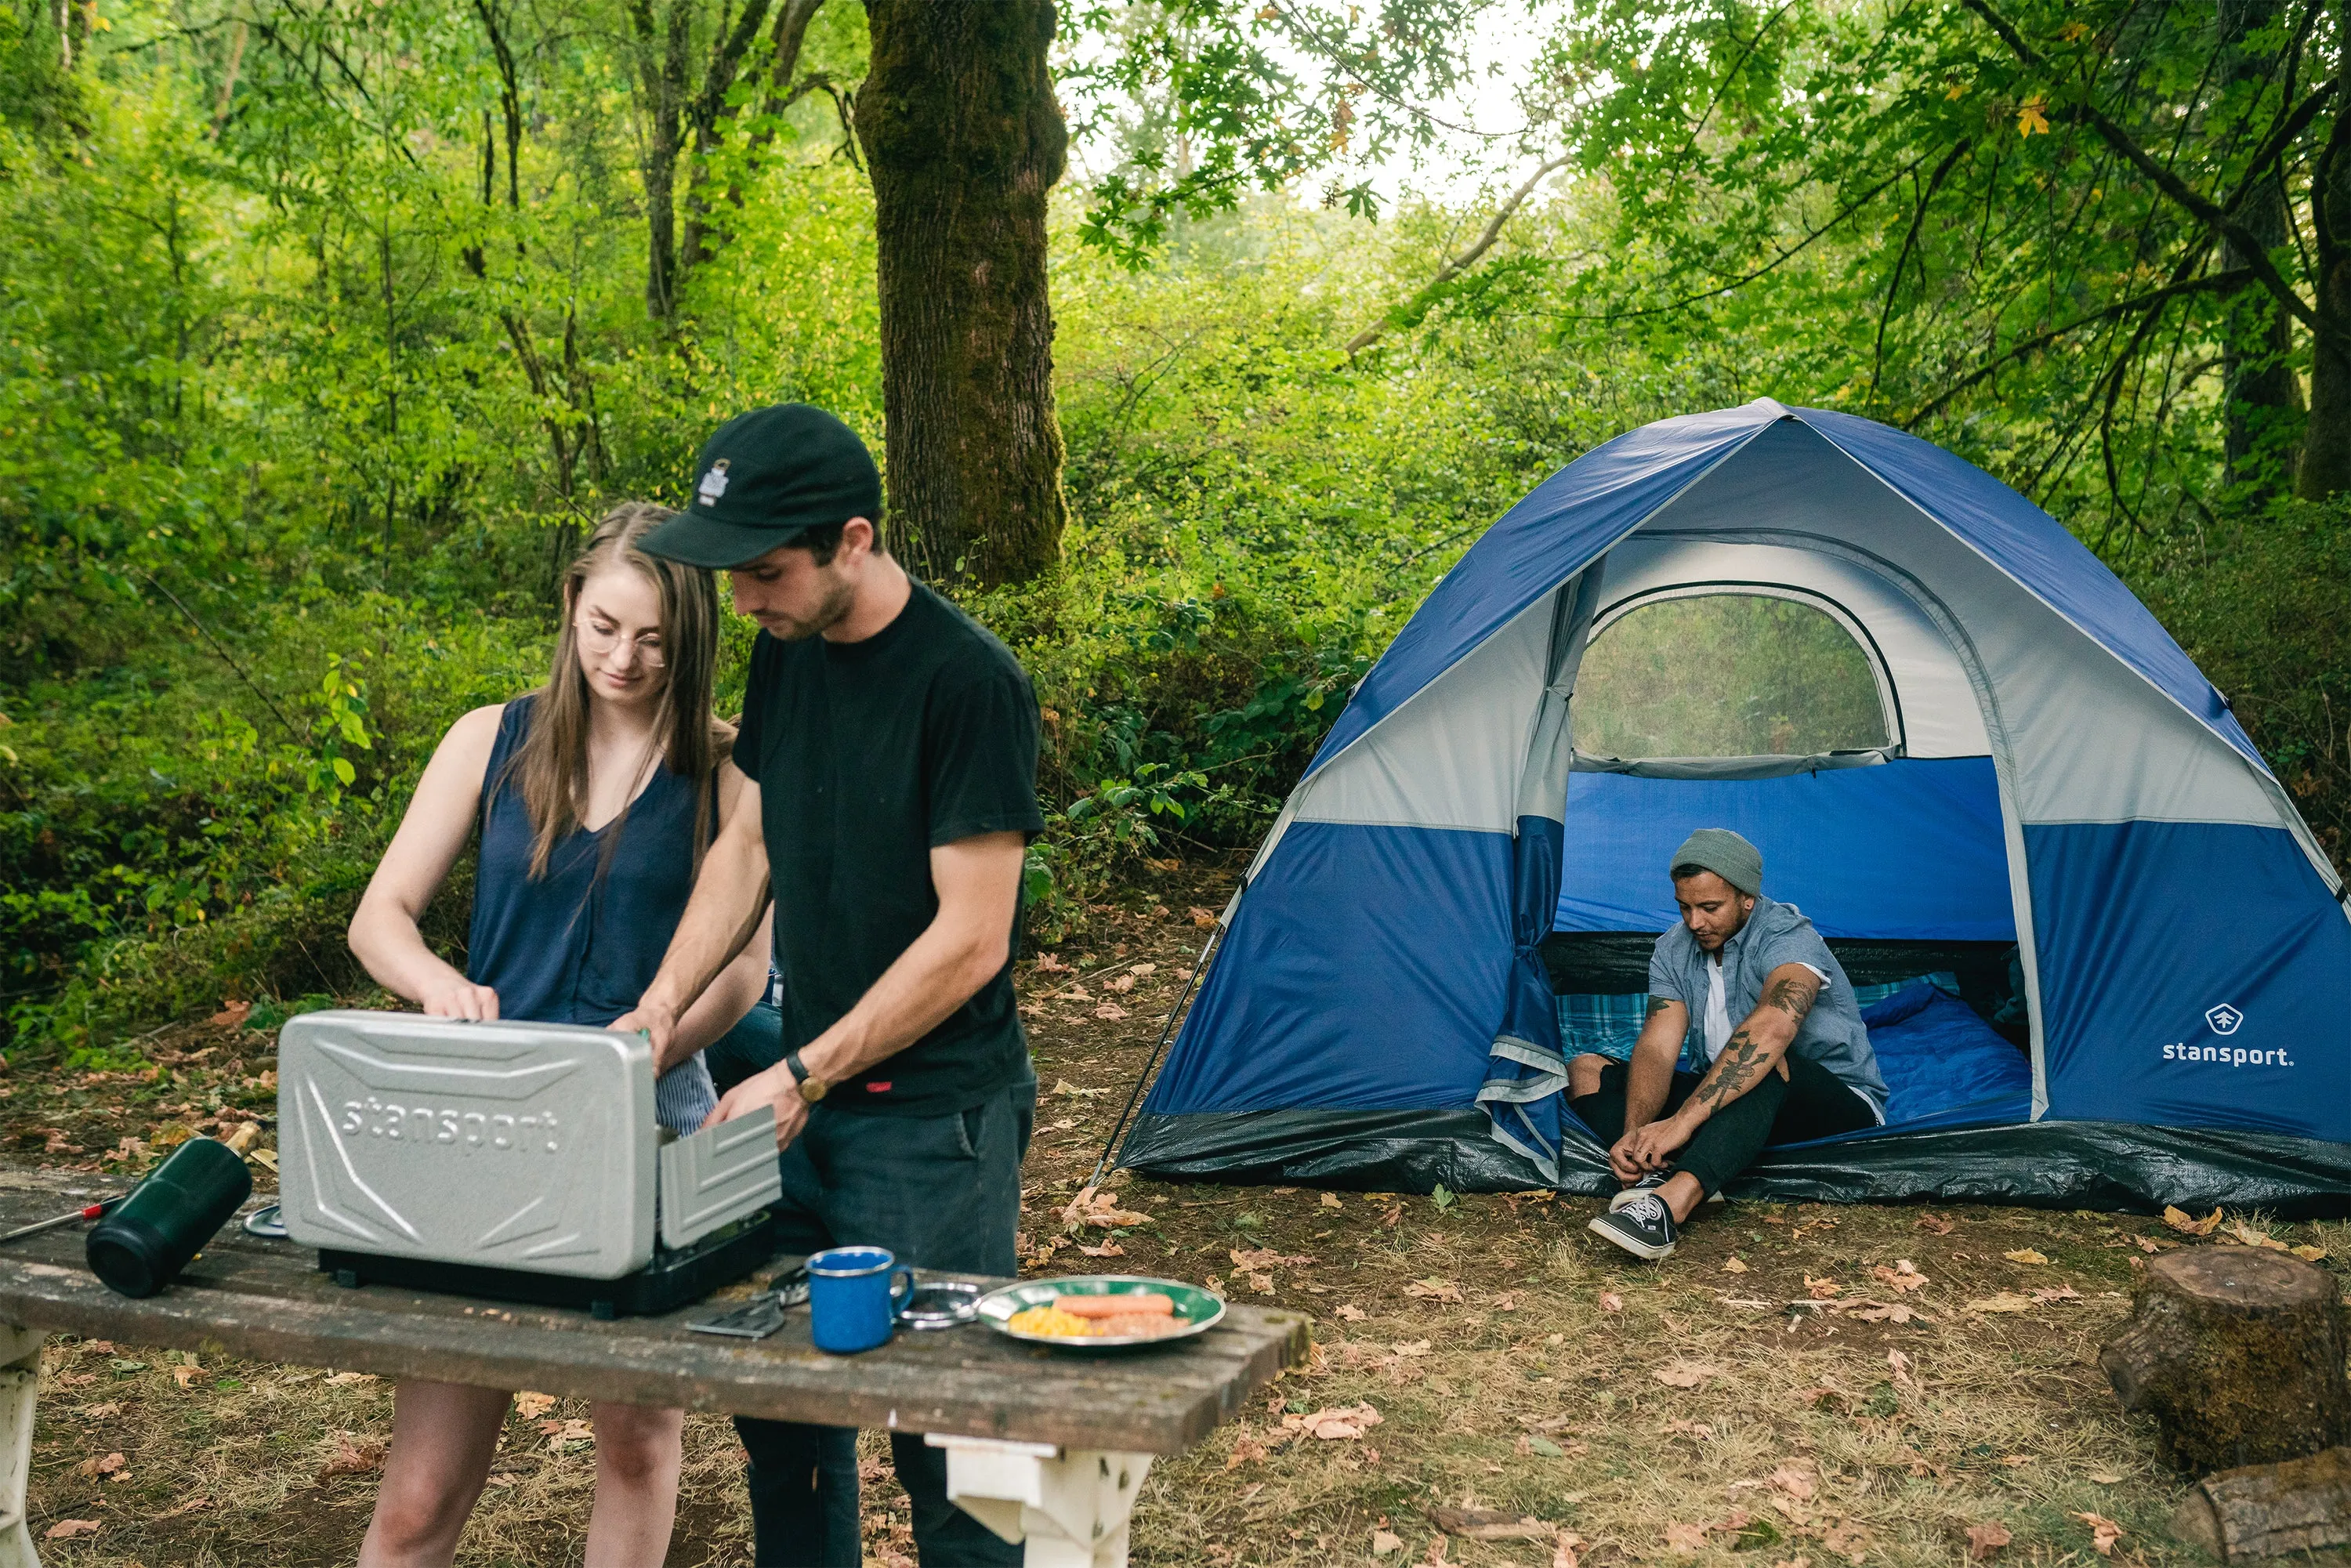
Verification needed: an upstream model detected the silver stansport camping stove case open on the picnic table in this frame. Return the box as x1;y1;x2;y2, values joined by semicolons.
277;1011;783;1312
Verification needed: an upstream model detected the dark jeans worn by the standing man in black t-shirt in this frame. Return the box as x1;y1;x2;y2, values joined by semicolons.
736;1079;1037;1568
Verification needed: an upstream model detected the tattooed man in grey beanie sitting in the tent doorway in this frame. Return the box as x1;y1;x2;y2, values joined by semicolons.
1568;827;1886;1258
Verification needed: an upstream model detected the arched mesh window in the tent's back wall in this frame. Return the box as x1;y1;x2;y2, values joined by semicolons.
1573;592;1895;759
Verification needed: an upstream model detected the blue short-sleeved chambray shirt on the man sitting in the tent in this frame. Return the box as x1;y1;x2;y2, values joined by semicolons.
1648;893;1886;1124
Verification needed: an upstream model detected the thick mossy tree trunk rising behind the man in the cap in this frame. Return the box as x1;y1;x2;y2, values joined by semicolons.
856;0;1067;588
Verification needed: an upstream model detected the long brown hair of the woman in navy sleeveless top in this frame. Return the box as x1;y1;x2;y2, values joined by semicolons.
489;501;731;882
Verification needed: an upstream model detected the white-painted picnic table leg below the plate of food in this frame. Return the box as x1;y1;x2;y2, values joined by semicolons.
924;1432;1152;1568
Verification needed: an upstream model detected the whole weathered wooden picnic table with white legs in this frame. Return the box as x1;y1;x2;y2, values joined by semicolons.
0;1168;1307;1568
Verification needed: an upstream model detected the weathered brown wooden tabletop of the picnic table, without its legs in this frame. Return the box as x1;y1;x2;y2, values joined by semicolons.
0;1171;1307;1455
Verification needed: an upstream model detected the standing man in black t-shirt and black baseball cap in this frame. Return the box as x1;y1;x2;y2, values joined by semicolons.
611;404;1044;1568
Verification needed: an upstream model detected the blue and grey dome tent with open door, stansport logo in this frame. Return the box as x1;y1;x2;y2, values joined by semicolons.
1119;400;2351;1213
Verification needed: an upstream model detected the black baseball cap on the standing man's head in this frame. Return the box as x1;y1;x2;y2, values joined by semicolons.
637;402;882;571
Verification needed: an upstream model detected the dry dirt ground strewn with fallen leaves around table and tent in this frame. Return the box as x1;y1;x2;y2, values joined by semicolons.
0;865;2351;1568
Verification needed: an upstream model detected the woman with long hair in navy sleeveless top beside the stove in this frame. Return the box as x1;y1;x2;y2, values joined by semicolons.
350;503;769;1568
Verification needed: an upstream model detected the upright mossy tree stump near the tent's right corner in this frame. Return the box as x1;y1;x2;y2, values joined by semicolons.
2097;1246;2351;1474
